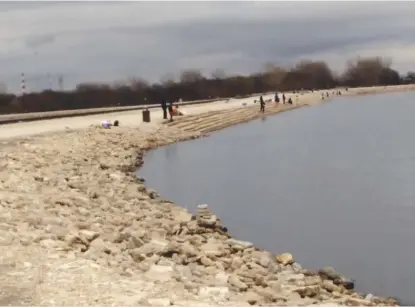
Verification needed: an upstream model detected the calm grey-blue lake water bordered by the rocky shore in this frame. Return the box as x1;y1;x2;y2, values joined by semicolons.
139;93;415;305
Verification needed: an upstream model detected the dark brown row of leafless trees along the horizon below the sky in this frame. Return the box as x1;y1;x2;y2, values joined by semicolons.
0;57;415;114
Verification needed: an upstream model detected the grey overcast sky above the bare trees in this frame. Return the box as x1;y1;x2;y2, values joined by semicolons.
0;1;415;91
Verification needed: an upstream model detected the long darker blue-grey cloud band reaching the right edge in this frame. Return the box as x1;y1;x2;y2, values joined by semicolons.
140;7;415;59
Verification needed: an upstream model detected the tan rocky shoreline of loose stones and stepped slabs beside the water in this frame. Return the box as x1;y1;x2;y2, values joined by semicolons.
0;103;398;306
